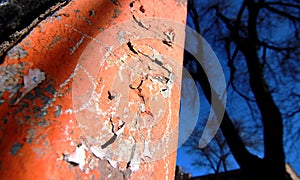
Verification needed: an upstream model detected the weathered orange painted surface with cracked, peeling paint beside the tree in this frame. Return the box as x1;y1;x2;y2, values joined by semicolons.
0;0;186;179
